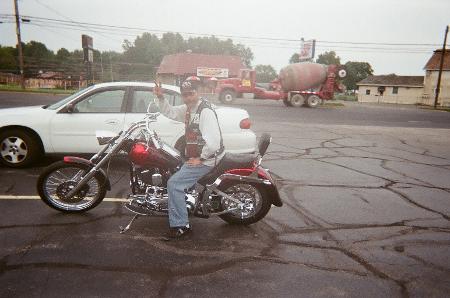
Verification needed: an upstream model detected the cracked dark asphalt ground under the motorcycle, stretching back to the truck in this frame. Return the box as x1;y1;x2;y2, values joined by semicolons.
0;93;450;297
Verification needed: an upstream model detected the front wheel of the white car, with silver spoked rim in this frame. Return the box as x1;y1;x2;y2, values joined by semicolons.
0;129;41;168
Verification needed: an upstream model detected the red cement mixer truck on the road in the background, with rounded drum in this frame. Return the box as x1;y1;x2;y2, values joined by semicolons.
215;62;346;108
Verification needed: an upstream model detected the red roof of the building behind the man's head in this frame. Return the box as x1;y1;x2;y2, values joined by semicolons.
158;53;246;76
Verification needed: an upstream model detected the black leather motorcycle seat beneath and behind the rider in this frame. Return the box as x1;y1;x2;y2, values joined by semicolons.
198;153;256;185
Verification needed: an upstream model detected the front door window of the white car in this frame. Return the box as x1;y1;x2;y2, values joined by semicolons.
75;90;125;113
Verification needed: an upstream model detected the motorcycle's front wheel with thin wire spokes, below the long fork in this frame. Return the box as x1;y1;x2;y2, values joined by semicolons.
37;161;106;213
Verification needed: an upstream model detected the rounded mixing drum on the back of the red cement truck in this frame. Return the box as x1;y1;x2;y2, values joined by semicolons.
279;62;328;92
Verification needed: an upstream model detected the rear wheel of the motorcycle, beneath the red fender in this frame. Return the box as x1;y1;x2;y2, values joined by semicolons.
220;182;271;225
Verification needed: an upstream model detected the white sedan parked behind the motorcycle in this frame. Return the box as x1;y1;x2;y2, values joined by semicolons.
0;82;256;167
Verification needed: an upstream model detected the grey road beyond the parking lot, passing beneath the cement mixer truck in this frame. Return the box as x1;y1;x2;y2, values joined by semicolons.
0;91;450;128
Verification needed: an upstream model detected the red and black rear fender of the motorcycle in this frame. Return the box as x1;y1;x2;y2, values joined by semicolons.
224;167;283;207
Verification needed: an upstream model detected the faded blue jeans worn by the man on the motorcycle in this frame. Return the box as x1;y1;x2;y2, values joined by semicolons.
167;164;212;228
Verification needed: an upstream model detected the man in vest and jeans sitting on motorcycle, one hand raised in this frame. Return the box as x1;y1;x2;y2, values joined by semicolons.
153;81;224;239
